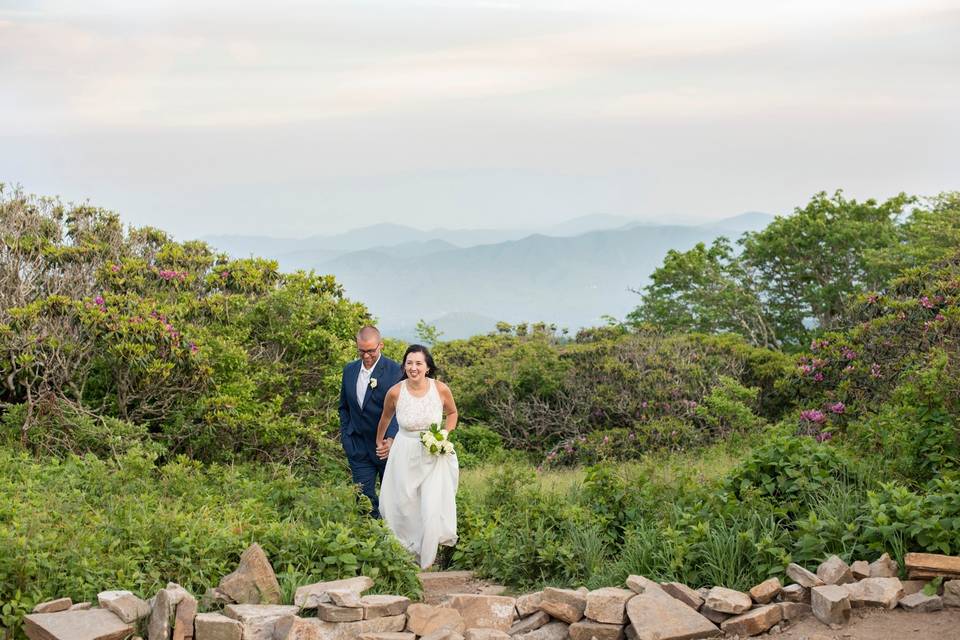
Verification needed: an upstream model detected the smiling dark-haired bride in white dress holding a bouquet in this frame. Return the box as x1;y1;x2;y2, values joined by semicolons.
377;344;460;569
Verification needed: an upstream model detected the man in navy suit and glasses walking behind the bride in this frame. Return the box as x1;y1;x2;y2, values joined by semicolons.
340;326;401;518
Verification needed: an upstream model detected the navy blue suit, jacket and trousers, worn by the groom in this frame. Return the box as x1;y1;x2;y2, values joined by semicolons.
340;355;403;518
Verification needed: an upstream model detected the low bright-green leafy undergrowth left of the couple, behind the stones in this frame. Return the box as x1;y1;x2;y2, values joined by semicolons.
0;448;419;627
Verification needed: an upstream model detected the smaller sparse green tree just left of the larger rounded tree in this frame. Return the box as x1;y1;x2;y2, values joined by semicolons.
627;236;776;347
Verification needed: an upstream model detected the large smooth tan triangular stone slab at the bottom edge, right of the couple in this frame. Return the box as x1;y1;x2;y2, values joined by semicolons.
627;576;720;640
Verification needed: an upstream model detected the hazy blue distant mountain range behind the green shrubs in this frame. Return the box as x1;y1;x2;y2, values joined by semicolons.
204;212;773;340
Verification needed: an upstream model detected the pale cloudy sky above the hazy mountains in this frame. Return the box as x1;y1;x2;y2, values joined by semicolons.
0;0;960;239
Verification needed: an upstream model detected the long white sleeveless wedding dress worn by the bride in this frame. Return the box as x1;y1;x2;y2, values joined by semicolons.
380;378;460;568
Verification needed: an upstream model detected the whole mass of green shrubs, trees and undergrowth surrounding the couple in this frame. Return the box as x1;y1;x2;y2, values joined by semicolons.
0;182;960;637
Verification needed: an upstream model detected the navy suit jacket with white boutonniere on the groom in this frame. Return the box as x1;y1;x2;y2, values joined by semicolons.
340;355;403;463
